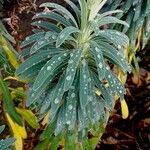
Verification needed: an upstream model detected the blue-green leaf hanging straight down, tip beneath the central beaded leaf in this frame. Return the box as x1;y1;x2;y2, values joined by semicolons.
65;86;77;130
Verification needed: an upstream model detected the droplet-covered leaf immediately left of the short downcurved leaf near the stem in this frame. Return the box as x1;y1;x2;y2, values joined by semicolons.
30;31;57;54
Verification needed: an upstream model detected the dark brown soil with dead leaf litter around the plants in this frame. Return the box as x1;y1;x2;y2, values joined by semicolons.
3;0;150;150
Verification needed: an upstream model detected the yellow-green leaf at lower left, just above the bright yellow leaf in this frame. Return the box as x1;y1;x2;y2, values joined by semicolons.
16;108;39;129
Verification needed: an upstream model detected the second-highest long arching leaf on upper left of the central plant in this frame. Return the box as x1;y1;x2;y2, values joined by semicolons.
33;12;71;26
